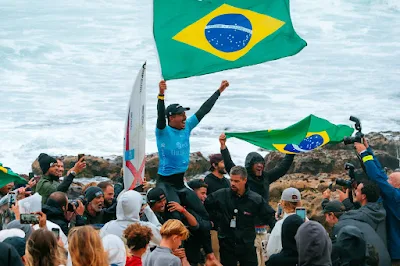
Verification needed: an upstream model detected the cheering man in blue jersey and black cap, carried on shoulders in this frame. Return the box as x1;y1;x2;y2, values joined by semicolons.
156;80;229;219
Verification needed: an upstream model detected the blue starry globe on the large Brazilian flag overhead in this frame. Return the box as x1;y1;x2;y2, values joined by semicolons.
205;14;253;53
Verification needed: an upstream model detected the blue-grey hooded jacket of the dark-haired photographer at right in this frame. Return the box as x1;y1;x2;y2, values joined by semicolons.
340;202;387;246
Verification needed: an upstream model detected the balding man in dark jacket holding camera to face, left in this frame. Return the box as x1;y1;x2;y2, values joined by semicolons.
42;192;85;236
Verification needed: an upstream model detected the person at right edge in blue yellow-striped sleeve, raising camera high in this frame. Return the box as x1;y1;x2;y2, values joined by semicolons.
354;139;400;265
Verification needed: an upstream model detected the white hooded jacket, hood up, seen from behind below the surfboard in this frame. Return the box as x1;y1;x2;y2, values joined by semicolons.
100;190;161;246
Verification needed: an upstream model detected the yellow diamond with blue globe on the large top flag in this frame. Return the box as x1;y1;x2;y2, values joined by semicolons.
172;4;285;61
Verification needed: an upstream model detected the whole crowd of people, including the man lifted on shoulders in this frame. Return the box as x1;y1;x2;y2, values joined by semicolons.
0;81;400;266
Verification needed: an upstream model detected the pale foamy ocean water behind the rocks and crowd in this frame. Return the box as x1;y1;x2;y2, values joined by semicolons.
0;0;400;175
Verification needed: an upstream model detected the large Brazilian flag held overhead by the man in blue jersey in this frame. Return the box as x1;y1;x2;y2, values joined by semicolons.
153;0;307;80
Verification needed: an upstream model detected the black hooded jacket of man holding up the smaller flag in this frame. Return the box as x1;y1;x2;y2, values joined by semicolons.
221;148;294;202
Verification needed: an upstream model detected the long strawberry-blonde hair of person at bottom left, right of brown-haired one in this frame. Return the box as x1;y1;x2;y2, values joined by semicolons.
68;225;109;266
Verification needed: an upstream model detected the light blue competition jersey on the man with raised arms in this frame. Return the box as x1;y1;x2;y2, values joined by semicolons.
156;115;199;176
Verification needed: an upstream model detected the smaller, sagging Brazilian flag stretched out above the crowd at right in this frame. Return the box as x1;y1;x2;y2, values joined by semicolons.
226;115;354;154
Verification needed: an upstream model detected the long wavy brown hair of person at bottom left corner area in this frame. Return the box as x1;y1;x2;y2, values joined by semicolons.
25;229;66;266
